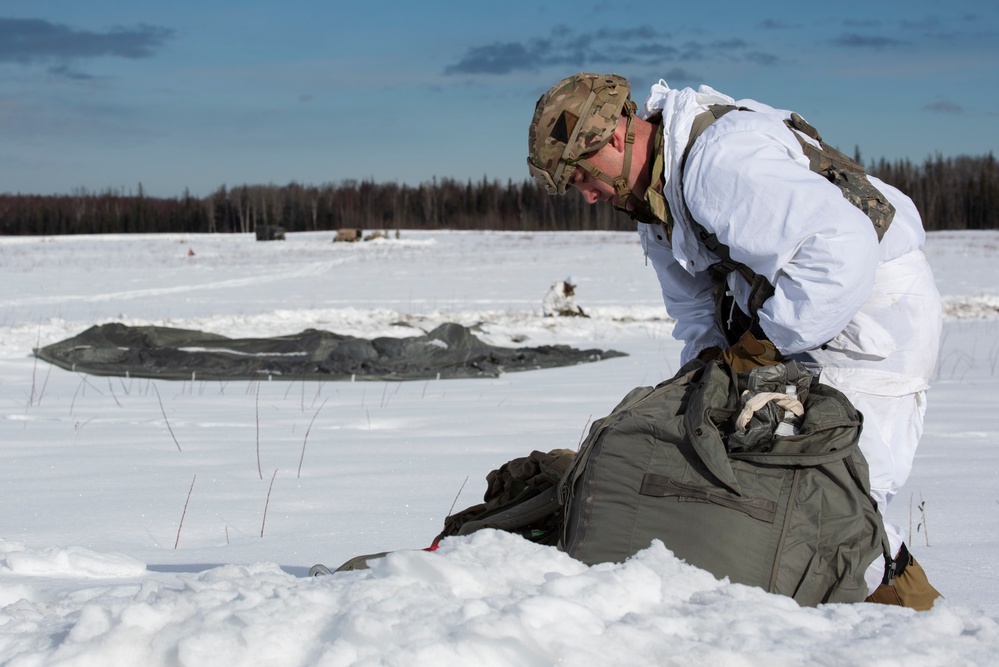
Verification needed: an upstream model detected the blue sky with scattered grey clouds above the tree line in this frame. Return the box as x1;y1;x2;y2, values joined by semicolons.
0;0;999;197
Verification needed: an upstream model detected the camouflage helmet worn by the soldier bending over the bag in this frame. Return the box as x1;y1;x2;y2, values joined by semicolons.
527;72;635;195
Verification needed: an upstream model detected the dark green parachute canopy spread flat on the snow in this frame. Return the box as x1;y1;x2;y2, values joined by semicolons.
35;323;626;380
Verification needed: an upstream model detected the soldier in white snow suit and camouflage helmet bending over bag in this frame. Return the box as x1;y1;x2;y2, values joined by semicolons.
527;73;942;609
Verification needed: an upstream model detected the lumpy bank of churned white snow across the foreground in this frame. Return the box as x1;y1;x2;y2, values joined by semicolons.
0;531;999;667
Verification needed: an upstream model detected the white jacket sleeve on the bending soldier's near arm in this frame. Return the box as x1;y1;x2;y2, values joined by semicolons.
684;112;880;354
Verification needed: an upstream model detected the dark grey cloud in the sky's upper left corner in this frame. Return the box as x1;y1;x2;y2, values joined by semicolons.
0;18;174;64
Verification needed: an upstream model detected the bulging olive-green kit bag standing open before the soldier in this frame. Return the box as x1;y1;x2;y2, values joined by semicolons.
559;361;887;605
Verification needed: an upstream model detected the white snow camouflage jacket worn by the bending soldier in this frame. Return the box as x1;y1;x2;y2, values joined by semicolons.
638;81;940;395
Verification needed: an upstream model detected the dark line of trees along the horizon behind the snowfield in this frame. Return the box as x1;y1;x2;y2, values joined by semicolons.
0;153;999;235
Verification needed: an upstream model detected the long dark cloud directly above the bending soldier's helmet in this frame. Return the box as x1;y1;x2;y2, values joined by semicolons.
444;26;779;75
